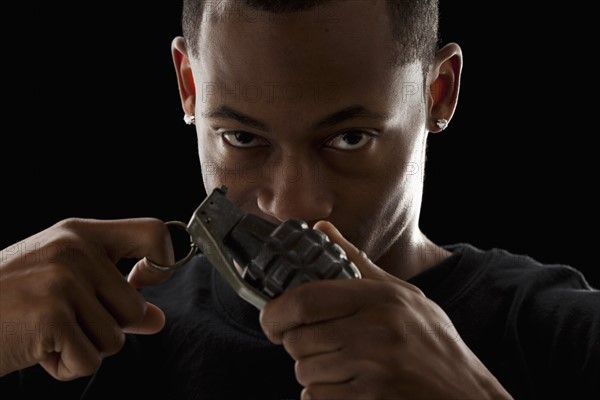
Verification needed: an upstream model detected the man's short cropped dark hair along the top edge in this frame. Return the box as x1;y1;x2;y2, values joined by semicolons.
181;0;439;66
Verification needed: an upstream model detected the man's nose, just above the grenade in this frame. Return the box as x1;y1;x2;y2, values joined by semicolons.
258;159;333;224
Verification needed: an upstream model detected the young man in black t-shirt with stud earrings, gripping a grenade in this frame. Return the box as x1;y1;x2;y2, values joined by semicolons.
0;0;600;399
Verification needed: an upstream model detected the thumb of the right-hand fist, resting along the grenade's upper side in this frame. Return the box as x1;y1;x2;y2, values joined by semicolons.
313;221;397;281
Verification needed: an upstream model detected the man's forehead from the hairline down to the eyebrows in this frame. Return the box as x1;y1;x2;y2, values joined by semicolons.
192;0;422;117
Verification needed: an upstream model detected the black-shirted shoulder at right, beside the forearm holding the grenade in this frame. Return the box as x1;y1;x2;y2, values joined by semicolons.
438;243;600;398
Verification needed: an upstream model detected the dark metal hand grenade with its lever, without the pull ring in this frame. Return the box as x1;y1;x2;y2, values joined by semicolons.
187;186;360;309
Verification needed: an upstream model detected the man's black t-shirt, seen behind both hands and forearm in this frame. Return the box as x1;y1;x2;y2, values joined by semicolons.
0;244;600;400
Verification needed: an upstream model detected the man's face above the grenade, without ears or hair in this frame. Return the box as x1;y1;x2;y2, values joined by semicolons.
191;2;427;266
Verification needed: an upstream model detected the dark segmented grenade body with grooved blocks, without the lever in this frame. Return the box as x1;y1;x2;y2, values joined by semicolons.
244;219;360;298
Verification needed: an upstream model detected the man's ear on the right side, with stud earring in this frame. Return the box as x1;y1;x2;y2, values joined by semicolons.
427;43;463;133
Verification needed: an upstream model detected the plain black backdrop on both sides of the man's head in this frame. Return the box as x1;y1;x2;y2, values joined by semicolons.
0;0;600;287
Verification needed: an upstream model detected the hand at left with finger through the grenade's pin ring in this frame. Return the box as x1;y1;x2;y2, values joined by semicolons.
0;218;174;380
